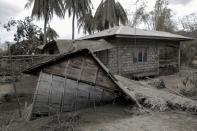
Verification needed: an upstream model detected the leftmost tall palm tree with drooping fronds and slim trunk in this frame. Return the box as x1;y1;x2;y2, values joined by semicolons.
25;0;64;44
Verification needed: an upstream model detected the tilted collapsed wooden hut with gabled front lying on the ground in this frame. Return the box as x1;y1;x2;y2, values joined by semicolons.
23;49;126;118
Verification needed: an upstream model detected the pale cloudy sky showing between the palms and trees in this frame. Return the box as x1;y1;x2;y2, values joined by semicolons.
0;0;197;47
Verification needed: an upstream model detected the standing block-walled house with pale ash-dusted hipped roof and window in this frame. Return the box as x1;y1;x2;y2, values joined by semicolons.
78;26;192;78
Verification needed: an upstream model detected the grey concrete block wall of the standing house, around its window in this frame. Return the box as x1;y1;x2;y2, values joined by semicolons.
98;39;159;76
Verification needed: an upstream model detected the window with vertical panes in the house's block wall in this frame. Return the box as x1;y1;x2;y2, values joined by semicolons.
133;48;147;63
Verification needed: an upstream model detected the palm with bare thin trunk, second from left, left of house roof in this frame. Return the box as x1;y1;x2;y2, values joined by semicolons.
65;0;92;40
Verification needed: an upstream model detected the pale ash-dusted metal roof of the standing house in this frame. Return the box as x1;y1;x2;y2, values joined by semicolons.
79;26;192;41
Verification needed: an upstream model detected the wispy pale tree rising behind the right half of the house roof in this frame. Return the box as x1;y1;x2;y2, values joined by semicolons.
135;0;176;32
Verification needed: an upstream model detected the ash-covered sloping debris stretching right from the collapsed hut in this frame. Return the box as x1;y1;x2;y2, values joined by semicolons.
116;76;197;112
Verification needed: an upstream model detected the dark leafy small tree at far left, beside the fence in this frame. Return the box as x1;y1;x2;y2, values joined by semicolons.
4;17;43;55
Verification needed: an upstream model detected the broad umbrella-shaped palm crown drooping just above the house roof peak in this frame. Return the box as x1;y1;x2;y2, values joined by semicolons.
94;0;128;31
